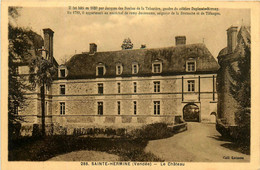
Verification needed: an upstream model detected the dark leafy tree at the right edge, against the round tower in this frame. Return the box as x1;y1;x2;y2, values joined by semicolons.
230;38;251;142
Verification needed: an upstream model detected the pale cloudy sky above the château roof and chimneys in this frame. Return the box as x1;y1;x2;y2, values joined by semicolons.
14;7;250;64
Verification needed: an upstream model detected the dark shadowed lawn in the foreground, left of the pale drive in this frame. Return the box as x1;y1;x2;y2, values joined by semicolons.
8;136;163;162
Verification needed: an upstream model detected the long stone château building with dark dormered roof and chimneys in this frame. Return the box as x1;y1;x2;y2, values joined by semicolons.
16;29;219;134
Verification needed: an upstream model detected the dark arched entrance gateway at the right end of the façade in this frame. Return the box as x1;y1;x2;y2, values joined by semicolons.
183;103;200;122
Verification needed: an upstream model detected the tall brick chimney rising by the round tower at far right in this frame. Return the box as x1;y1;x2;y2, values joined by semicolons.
227;26;238;53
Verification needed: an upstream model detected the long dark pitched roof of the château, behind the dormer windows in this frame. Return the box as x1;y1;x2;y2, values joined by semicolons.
65;44;219;79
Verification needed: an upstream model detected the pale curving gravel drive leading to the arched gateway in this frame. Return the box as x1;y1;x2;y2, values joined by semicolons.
145;122;250;162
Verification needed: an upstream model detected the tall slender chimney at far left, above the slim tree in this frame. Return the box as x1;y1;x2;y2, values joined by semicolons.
43;28;54;61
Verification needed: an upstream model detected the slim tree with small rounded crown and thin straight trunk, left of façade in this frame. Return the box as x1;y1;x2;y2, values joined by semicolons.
29;56;56;136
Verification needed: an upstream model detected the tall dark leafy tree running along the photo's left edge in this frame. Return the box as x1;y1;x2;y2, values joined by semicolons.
8;7;33;140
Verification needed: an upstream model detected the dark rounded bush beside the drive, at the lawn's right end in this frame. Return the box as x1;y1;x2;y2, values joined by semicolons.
130;123;173;140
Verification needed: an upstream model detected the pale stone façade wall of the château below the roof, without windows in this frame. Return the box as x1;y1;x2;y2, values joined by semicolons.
16;75;217;135
